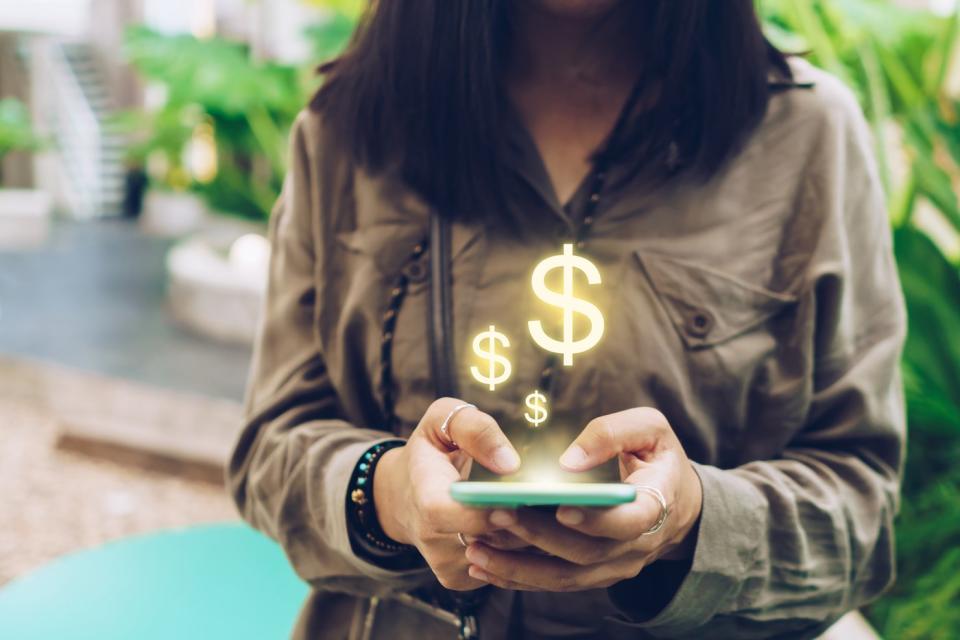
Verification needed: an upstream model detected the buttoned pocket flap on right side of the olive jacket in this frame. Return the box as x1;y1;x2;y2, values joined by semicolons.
634;251;797;349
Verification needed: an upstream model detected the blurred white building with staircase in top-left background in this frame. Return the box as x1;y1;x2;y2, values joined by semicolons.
0;0;318;218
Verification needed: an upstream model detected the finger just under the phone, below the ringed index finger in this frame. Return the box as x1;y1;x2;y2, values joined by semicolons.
507;509;625;565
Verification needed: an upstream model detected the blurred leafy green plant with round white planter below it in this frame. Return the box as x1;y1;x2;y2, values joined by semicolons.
125;14;353;342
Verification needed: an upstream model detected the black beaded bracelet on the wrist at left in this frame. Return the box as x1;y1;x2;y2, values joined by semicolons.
346;440;423;569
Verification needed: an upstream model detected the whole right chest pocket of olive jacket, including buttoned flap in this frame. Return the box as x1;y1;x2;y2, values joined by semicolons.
600;249;804;465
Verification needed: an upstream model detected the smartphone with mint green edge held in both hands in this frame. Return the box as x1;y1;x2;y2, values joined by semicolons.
450;480;637;507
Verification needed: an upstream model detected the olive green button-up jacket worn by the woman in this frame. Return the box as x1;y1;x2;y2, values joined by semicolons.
228;59;906;639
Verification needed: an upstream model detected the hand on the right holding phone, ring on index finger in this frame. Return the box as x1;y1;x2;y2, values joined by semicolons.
466;407;702;591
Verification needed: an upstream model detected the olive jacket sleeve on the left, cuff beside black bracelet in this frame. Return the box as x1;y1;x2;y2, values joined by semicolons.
226;114;432;595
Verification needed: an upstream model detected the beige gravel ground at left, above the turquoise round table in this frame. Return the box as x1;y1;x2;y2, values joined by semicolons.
0;398;237;585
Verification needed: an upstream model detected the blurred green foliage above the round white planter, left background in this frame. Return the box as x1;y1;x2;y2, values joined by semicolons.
125;27;305;218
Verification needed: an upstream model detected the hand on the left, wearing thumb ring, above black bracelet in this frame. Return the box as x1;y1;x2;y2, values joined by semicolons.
373;398;528;590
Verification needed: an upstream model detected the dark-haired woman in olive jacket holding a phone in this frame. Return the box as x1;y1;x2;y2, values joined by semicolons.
229;0;905;639
